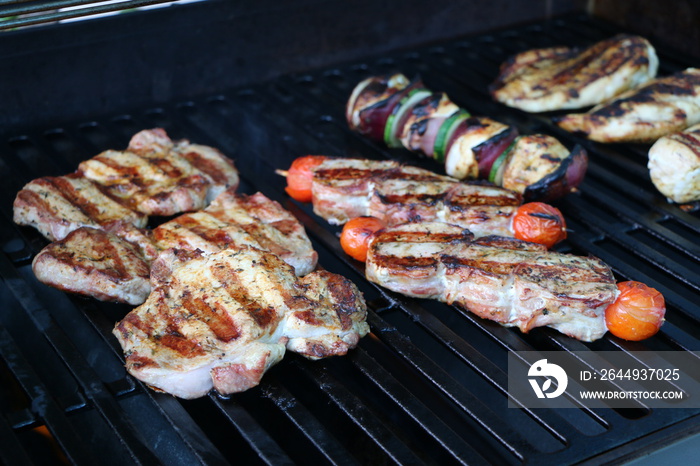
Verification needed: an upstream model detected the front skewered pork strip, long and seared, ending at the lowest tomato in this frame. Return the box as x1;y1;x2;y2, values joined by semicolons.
365;222;618;341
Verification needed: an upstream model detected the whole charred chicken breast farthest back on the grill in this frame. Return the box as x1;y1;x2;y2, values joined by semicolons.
490;34;659;112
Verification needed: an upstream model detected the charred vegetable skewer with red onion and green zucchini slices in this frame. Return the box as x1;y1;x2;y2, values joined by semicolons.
346;73;588;201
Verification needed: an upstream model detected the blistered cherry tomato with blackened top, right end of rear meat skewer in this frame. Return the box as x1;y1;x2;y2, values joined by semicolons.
513;202;566;248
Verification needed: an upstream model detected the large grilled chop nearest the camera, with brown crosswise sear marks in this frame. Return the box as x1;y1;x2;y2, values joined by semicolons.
114;248;369;398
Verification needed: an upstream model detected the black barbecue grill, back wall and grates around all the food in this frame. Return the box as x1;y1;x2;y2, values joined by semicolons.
0;1;700;465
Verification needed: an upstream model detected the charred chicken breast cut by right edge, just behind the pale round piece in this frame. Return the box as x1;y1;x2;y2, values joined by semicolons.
555;68;700;143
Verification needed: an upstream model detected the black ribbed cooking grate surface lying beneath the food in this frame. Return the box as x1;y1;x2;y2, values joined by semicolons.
0;9;700;464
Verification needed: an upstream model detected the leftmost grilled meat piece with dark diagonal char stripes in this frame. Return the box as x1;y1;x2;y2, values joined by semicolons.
13;174;148;241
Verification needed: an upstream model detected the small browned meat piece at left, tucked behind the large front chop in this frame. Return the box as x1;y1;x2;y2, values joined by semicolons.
32;227;151;305
